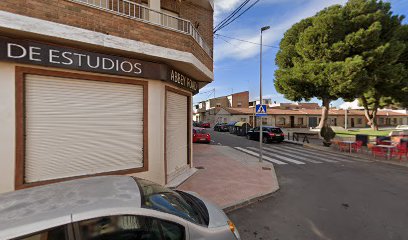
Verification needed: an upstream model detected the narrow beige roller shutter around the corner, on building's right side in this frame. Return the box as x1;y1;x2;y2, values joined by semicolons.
166;91;188;182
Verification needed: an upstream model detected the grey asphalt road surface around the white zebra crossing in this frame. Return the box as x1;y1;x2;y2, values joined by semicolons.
212;129;408;240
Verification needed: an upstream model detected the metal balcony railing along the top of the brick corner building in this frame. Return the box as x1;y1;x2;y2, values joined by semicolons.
70;0;212;58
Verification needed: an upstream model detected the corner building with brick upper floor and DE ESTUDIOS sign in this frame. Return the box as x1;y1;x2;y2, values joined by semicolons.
0;0;213;192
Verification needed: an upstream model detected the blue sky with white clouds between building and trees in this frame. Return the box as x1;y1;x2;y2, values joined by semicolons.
193;0;408;107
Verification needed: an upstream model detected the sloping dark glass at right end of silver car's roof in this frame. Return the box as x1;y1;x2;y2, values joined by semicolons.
135;178;208;225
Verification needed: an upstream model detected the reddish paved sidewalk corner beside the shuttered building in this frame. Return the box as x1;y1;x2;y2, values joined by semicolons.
178;144;279;211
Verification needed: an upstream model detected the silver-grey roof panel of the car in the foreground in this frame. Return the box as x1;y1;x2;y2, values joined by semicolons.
0;176;141;239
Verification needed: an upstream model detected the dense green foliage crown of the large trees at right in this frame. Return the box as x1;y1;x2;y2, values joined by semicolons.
275;0;408;112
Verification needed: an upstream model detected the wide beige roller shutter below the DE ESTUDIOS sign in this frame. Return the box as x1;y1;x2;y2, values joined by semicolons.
25;75;143;182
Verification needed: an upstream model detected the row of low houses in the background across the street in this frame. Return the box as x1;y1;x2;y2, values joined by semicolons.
193;92;408;128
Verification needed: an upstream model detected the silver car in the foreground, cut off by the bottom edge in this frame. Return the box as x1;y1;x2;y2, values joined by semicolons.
0;176;240;240
